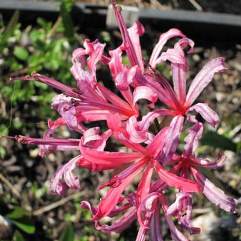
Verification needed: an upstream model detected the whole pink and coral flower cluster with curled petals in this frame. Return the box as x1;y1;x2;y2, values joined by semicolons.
16;1;236;241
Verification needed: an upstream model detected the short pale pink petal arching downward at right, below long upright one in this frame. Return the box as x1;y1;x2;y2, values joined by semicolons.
189;103;219;127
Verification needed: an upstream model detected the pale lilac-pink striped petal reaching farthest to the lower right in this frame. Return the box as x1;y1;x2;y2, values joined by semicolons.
192;168;236;212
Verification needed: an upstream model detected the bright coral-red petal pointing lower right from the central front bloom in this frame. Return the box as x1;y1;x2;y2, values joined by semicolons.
155;161;199;192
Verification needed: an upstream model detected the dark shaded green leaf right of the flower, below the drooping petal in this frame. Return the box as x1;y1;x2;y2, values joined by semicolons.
201;131;237;152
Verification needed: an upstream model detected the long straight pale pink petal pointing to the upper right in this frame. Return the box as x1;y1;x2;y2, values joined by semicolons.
186;57;226;106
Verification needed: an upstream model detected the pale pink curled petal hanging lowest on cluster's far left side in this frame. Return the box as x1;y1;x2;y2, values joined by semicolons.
50;156;82;195
